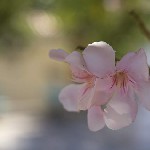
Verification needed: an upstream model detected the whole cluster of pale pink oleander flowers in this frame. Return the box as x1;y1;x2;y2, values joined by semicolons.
50;41;150;131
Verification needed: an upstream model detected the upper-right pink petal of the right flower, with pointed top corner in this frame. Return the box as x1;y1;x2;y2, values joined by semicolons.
116;49;149;81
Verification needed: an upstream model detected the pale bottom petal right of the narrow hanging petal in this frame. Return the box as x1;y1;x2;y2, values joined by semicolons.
104;106;132;130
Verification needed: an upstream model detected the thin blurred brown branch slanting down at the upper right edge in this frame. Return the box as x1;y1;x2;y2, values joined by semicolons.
130;10;150;40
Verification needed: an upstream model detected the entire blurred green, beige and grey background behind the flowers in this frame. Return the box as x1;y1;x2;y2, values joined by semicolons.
0;0;150;150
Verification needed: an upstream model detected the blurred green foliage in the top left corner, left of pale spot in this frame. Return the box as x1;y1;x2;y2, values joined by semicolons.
0;0;30;50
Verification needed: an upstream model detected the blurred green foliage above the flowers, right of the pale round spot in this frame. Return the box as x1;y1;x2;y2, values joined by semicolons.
53;0;150;58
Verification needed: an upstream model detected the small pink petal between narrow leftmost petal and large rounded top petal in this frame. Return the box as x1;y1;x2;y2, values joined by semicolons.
65;51;86;70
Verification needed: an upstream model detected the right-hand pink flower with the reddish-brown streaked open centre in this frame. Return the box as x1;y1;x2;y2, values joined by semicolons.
83;42;150;129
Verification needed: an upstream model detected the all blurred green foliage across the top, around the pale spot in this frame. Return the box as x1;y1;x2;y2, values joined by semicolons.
0;0;150;58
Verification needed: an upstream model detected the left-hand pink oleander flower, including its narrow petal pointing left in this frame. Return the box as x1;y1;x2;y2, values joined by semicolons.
50;45;114;111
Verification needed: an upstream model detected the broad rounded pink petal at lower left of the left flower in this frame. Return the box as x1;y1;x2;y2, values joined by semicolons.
59;83;94;111
